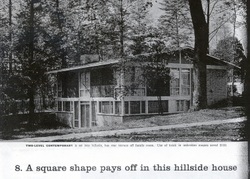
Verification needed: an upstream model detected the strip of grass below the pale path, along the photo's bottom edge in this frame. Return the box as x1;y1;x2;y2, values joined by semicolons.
65;123;245;142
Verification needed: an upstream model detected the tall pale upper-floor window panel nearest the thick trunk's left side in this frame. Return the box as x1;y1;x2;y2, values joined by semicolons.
181;69;191;95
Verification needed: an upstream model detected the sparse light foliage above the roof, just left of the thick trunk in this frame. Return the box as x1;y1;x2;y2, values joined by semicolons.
159;0;193;50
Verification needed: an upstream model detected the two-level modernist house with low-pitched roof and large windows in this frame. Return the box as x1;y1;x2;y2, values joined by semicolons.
50;49;230;128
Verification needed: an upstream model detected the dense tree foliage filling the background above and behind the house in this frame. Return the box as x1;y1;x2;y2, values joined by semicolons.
0;0;245;114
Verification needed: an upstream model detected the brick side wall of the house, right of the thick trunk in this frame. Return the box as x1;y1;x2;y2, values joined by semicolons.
207;69;227;105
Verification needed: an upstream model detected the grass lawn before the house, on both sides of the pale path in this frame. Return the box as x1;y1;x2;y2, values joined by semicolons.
0;107;244;141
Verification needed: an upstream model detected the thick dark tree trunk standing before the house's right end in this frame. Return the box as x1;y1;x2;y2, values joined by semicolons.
189;0;208;110
